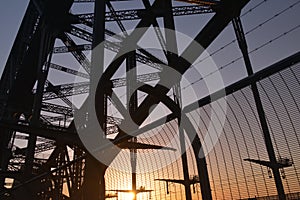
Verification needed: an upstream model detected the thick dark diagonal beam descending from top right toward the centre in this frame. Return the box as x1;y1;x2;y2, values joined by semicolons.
133;0;249;124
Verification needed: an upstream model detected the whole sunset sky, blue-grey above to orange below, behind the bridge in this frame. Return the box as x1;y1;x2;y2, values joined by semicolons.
0;0;300;199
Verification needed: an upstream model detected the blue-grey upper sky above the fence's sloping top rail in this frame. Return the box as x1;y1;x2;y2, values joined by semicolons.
0;0;300;83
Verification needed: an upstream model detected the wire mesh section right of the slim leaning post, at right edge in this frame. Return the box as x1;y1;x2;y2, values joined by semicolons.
259;66;300;193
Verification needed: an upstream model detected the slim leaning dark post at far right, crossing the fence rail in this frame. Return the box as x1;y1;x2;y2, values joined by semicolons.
232;17;286;200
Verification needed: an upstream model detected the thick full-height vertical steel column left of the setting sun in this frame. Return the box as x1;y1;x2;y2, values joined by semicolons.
83;0;107;200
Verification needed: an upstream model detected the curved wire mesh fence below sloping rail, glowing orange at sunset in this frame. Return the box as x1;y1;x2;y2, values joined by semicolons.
106;65;300;199
